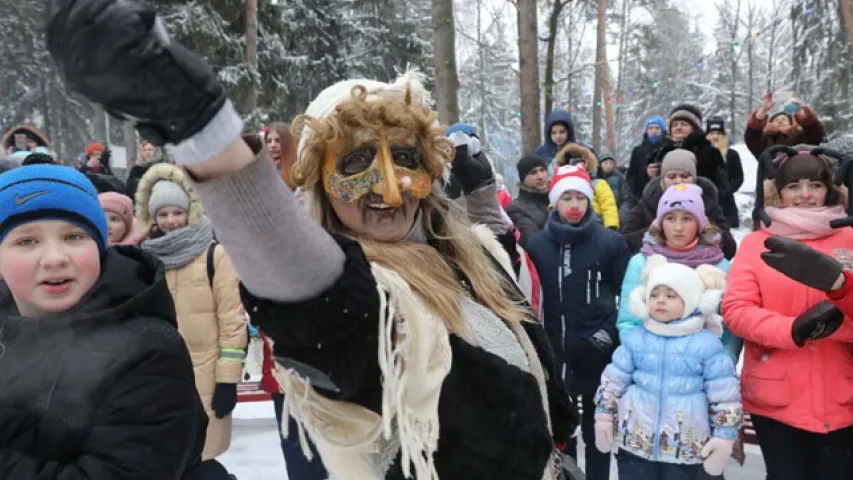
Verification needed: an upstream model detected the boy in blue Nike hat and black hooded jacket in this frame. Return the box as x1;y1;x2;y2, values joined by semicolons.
0;165;207;480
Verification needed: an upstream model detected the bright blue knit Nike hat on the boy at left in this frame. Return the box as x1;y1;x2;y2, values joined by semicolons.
0;164;108;253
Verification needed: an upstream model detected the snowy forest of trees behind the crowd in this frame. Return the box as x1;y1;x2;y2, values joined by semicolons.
0;0;853;184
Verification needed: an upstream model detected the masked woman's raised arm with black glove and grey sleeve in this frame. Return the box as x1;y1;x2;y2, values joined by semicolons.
47;0;344;301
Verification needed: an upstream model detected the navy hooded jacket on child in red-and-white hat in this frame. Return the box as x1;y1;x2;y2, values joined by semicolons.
527;208;631;394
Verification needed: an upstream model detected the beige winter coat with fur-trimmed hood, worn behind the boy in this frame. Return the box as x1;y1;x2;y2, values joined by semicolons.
136;164;248;460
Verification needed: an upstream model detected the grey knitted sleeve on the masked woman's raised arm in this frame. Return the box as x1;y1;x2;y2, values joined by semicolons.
194;153;344;302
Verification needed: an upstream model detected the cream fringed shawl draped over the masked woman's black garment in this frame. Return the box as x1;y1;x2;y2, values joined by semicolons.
273;226;553;480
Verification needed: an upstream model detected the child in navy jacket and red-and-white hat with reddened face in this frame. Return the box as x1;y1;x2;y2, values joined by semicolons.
528;165;631;480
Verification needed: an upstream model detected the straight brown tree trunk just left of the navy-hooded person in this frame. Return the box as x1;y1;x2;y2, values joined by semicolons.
516;0;542;152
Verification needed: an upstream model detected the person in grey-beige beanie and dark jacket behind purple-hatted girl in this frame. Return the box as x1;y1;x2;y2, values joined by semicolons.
621;149;737;260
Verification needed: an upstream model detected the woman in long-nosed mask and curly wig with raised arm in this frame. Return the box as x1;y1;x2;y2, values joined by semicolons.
48;0;576;480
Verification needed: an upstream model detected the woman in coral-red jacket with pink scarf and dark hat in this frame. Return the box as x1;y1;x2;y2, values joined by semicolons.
723;147;853;480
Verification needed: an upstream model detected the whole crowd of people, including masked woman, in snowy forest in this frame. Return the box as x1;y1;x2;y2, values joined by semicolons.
0;0;853;480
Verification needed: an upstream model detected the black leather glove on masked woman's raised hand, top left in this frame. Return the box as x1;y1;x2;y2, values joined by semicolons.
47;0;226;145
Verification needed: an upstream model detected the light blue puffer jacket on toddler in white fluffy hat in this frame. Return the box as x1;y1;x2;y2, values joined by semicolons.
595;312;743;464
